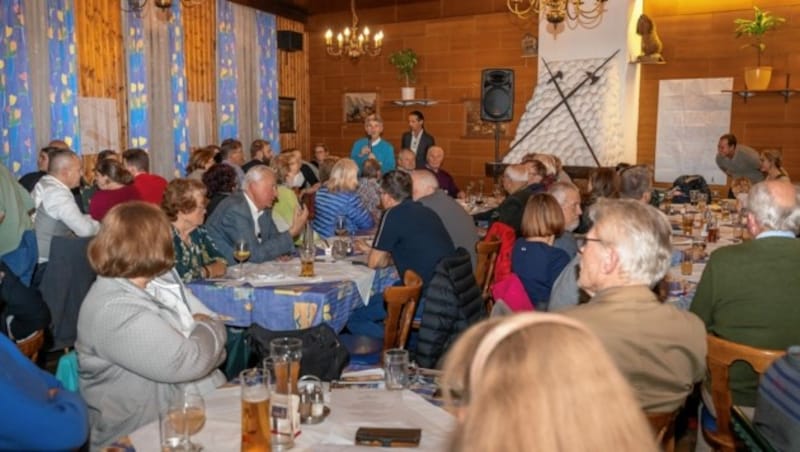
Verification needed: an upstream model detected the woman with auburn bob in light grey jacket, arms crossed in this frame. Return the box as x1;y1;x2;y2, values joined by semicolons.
75;201;226;450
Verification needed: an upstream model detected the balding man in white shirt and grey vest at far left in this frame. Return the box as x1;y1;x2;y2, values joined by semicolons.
33;149;100;262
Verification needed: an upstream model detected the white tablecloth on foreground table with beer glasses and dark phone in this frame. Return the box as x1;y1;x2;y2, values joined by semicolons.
130;386;454;452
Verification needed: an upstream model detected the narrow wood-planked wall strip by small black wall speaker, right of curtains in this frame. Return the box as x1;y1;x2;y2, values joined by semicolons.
276;17;311;155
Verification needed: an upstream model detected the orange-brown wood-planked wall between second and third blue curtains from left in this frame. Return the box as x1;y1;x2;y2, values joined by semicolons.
75;0;128;159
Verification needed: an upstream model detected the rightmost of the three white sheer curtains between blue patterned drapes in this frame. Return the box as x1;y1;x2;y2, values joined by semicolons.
232;3;261;153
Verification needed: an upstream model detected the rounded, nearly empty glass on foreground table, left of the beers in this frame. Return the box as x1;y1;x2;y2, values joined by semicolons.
160;391;206;452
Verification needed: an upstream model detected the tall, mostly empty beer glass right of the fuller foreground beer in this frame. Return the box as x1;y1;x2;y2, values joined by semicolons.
265;337;303;451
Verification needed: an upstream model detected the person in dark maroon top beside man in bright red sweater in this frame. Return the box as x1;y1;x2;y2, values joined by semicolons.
89;159;141;221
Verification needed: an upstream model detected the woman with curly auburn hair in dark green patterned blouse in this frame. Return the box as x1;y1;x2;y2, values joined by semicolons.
161;179;227;282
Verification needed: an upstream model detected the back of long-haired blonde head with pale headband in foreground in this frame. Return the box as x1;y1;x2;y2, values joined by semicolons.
442;313;658;452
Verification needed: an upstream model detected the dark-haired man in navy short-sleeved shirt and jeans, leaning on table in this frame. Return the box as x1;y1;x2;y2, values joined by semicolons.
347;171;455;337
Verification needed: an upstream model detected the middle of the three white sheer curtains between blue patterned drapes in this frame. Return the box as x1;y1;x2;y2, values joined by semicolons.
142;2;175;180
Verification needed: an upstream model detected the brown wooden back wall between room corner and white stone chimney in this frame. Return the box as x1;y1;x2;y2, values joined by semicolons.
306;7;537;190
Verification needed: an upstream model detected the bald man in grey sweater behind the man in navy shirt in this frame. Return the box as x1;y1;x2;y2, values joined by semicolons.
411;170;478;269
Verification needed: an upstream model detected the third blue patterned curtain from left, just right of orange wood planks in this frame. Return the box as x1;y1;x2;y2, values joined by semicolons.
120;0;150;150
